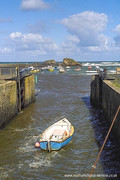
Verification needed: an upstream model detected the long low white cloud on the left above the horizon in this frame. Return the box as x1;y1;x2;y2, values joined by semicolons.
10;32;58;54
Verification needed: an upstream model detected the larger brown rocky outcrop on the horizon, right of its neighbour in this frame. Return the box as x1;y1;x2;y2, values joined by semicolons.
62;58;81;66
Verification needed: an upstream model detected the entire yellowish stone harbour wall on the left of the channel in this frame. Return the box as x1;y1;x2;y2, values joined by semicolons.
0;67;35;129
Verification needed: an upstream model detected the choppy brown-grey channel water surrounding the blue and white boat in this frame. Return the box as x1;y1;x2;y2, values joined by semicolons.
0;73;120;180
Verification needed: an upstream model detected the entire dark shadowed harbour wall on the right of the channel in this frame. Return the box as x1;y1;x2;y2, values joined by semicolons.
90;74;120;135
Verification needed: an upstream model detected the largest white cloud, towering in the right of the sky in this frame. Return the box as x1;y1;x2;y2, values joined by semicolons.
61;11;108;47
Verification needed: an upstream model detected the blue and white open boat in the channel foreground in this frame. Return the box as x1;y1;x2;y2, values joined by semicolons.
35;118;74;152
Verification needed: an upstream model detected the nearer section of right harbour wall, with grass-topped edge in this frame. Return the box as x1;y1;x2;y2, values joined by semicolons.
102;80;120;135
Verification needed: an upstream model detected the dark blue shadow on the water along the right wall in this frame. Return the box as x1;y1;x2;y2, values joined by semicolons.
82;96;120;180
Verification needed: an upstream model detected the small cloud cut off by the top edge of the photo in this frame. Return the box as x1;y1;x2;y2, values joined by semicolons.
21;0;50;11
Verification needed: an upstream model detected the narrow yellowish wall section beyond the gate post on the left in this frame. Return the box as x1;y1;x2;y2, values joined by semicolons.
24;75;35;107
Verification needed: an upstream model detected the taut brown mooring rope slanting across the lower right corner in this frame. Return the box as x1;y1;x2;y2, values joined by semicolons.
88;105;120;180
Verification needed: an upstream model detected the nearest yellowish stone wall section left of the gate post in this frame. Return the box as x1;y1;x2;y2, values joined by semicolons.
0;81;18;129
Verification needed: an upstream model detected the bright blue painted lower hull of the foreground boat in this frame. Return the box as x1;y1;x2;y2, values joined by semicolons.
40;136;72;151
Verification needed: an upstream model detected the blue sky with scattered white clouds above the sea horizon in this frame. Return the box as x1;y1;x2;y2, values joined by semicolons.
0;0;120;62
